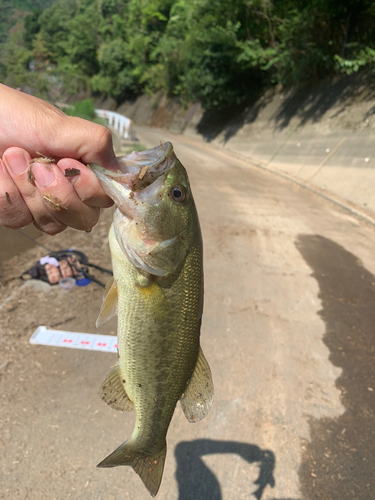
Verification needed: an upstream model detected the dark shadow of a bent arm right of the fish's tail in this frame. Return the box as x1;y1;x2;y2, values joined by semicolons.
175;439;294;500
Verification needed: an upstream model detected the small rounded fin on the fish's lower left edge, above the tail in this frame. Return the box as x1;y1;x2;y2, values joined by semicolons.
99;363;134;411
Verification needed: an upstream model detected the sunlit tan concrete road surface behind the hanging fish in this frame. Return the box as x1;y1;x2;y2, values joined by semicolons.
0;129;375;500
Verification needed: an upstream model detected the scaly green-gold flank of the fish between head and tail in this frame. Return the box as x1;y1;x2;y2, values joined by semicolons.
110;227;202;453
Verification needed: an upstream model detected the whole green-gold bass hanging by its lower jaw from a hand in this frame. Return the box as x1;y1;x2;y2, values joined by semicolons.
90;142;214;497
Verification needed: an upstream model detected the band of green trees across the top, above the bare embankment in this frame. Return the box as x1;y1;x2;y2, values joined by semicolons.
0;0;375;110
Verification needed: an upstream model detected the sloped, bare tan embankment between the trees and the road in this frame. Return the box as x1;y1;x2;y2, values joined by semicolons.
97;75;375;216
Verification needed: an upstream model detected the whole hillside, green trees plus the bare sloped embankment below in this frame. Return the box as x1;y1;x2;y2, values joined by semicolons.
0;0;375;218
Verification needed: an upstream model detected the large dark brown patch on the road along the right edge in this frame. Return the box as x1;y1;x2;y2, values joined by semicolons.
296;235;375;500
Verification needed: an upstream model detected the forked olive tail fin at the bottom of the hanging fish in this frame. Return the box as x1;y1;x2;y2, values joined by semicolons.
97;440;167;497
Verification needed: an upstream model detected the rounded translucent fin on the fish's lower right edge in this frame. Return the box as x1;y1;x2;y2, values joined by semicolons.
180;348;214;422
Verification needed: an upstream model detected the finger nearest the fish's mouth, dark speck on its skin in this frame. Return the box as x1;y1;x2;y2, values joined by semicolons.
57;158;113;208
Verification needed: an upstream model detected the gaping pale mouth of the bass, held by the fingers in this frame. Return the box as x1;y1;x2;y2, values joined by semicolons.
90;142;176;218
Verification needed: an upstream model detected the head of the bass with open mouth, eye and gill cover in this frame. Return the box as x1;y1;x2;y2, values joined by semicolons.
91;142;199;276
